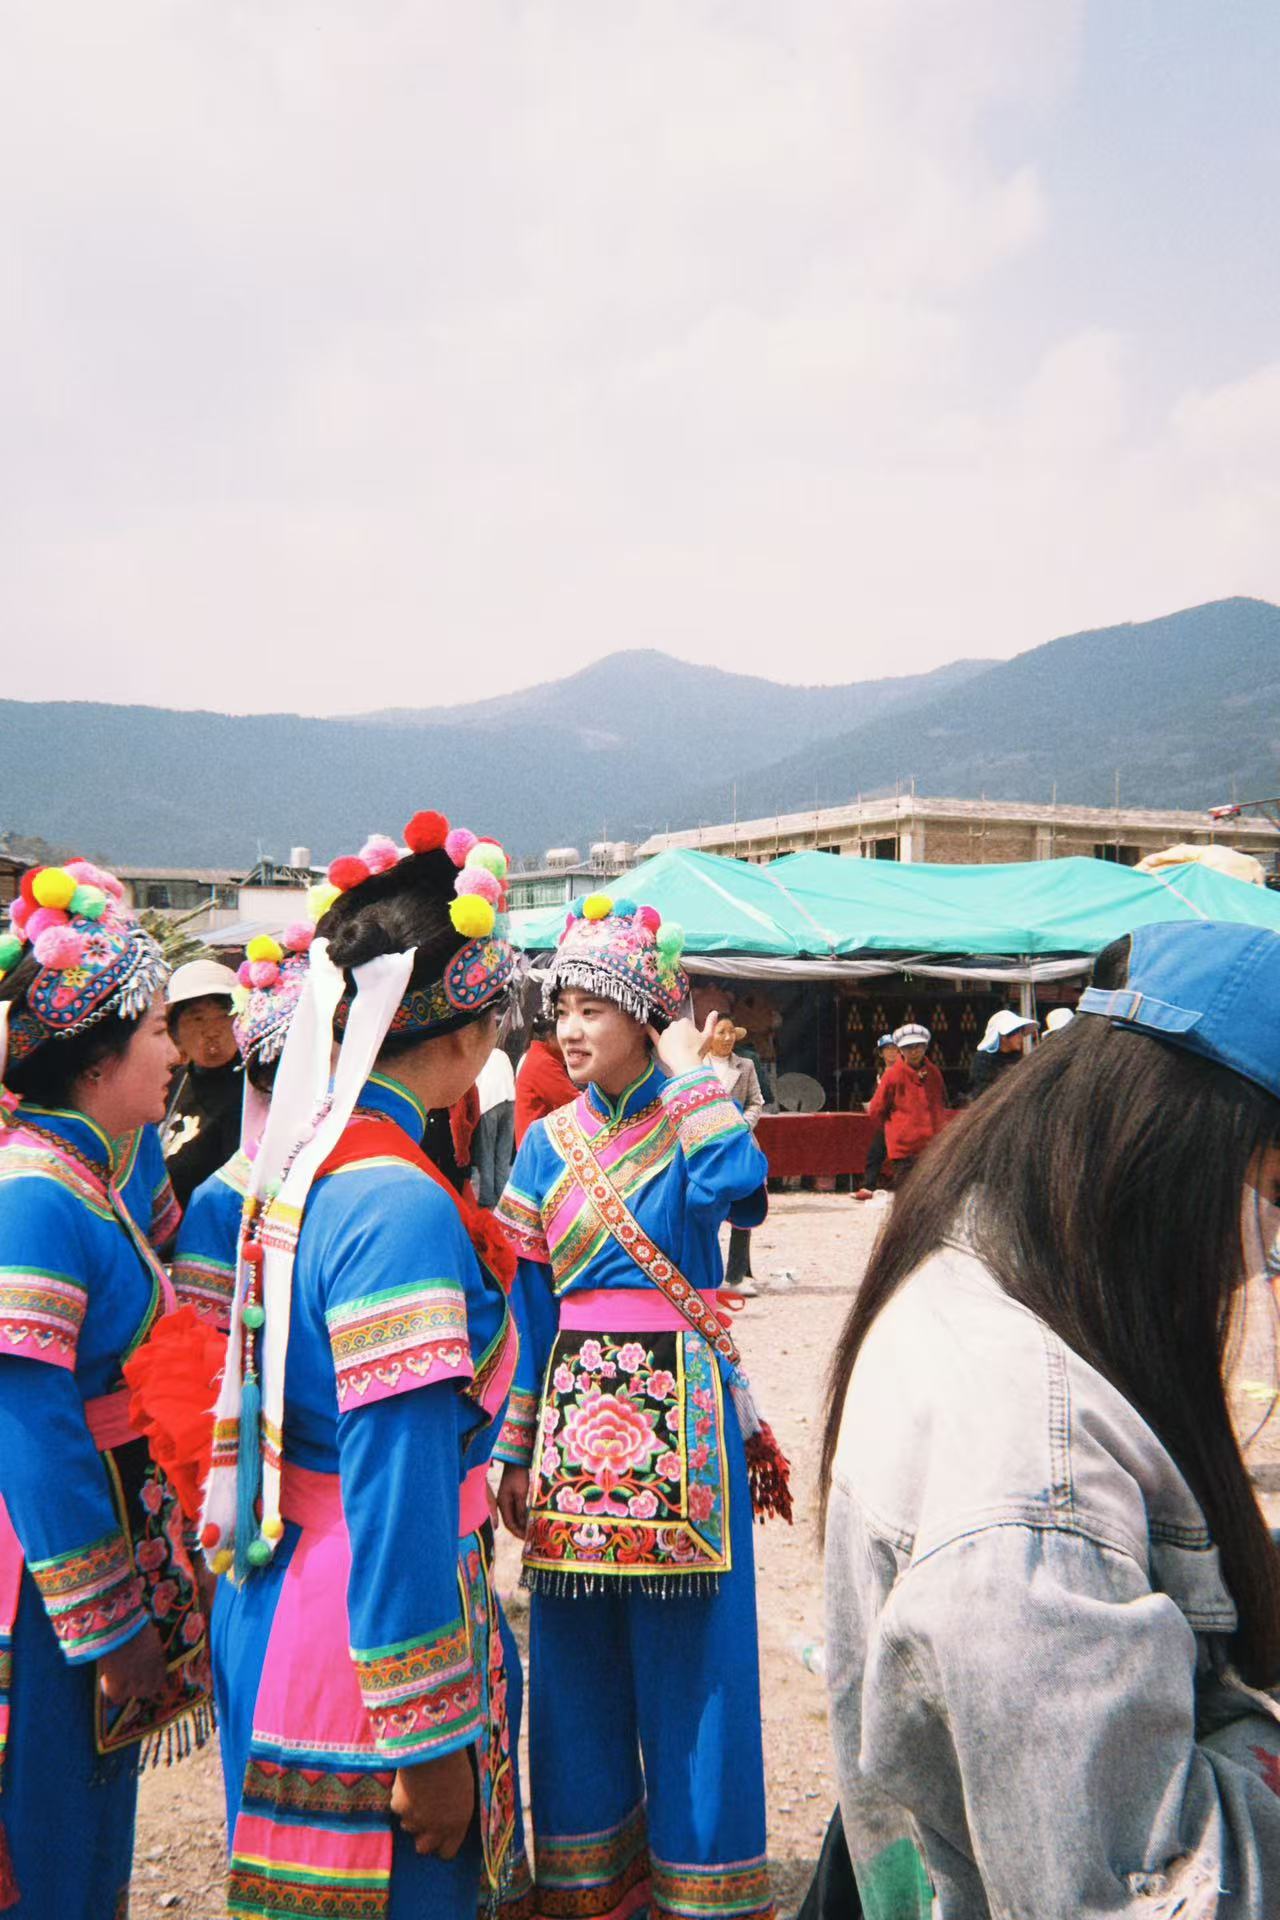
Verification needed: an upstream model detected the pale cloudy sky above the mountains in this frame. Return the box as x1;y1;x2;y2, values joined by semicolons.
0;0;1280;714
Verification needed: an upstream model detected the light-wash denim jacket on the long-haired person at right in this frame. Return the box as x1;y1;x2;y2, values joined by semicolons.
827;1248;1280;1920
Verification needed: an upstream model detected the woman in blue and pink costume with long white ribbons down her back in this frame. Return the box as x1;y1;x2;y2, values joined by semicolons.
203;814;529;1920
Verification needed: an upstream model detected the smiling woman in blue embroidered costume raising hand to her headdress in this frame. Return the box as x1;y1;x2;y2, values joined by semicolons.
497;895;785;1920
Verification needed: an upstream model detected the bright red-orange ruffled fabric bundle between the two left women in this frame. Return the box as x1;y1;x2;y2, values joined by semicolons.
125;1306;226;1521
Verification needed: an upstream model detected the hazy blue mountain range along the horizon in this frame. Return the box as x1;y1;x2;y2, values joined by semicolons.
0;599;1280;868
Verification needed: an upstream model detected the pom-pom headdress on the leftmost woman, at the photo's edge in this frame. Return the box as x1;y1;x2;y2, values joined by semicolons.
0;860;169;1073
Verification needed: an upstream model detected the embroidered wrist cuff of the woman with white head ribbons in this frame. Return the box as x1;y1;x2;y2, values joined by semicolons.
351;1620;484;1766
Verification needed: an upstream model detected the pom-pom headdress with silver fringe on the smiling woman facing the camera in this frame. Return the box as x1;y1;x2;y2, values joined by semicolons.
543;893;689;1025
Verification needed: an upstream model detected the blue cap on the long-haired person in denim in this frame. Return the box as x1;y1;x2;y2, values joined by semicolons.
1079;920;1280;1100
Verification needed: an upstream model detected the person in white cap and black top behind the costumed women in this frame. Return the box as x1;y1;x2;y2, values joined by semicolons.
163;960;244;1208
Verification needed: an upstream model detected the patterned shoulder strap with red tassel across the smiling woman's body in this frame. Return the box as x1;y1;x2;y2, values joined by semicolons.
547;1102;791;1524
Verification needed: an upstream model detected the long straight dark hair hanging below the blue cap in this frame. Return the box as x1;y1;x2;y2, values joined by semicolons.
819;943;1280;1686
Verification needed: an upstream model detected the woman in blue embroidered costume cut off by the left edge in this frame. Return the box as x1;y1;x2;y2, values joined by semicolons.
0;862;203;1920
